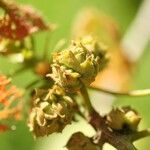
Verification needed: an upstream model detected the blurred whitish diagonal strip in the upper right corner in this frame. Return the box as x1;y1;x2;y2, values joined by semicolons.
122;0;150;62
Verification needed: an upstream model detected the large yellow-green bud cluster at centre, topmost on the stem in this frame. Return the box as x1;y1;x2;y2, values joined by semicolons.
48;36;107;91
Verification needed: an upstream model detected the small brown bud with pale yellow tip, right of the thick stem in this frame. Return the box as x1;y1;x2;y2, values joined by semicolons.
107;107;141;132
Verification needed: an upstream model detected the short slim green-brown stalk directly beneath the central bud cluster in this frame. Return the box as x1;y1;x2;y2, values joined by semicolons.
80;84;94;113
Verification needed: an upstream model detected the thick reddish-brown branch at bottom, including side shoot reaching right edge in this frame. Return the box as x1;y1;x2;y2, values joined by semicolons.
89;112;150;150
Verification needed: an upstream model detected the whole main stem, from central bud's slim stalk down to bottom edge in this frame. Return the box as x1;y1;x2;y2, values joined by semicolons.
80;85;137;150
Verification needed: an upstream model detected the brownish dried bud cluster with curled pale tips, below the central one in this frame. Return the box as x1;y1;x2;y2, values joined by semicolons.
28;85;75;137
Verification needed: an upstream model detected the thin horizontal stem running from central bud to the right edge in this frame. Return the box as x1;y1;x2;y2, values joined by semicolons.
89;87;150;97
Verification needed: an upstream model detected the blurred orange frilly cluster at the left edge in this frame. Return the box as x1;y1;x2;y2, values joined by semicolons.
0;75;22;129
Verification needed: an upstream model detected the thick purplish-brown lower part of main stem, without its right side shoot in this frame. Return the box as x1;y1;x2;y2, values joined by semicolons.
89;109;139;150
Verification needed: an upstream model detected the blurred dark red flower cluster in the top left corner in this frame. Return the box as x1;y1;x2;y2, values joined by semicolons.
0;0;49;40
